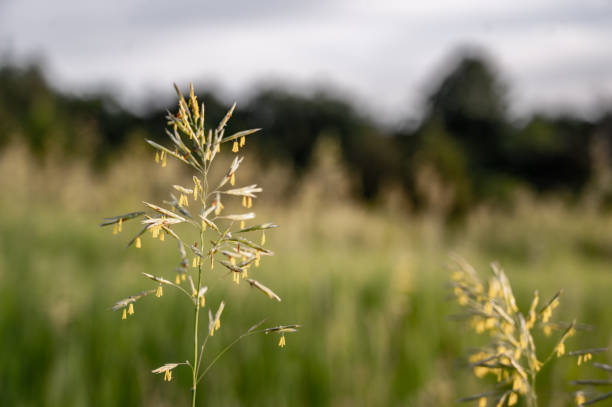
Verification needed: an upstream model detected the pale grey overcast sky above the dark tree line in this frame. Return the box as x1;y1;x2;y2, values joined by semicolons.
0;0;612;120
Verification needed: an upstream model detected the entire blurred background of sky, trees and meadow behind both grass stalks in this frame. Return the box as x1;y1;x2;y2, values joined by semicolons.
0;0;612;406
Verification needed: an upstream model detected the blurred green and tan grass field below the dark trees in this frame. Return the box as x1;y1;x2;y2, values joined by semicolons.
0;145;612;406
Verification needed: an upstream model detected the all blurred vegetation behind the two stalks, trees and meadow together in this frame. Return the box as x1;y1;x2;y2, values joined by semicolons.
0;51;612;406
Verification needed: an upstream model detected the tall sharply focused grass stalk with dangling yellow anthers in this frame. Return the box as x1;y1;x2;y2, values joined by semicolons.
101;85;299;406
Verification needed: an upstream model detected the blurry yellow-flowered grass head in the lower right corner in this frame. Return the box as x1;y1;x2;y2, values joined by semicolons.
452;260;606;407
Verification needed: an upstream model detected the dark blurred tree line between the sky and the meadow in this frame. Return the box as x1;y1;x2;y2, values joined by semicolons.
0;51;612;215
